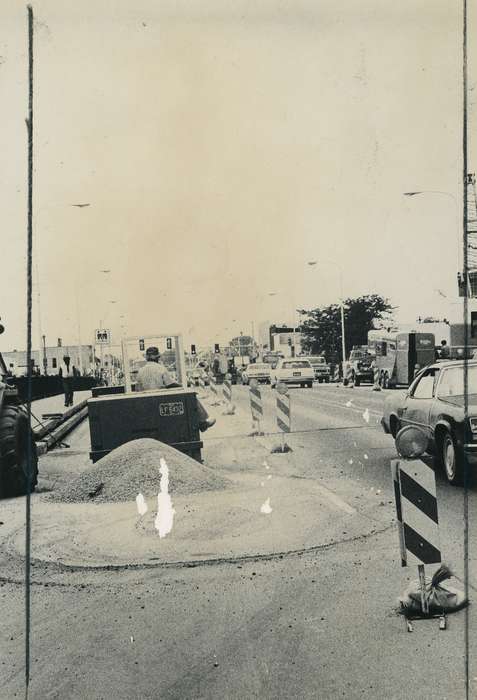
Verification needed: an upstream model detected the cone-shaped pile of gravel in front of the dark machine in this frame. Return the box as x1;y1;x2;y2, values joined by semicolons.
48;438;231;503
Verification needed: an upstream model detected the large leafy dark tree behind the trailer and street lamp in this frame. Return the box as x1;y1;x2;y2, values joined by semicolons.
300;294;394;363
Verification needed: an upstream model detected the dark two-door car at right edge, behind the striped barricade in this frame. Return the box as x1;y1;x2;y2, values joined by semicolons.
381;360;477;484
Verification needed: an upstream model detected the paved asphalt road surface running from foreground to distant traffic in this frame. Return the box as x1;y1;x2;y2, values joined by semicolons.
0;385;477;700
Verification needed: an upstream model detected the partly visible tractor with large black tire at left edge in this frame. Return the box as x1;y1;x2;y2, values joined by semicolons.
0;325;38;498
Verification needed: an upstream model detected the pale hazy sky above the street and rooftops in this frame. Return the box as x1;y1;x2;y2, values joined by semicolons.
0;0;477;350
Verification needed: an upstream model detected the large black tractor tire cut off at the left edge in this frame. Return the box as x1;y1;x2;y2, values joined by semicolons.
0;406;38;498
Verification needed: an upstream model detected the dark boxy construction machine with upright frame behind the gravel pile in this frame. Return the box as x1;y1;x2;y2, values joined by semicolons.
88;334;203;462
